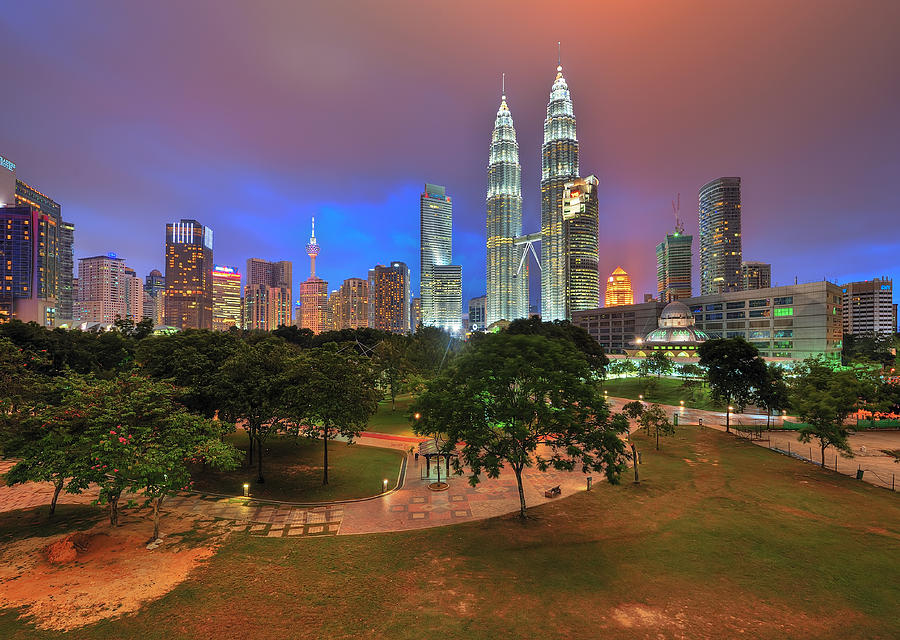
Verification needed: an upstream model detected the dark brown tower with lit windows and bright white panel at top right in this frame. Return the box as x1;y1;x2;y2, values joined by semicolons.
164;219;213;329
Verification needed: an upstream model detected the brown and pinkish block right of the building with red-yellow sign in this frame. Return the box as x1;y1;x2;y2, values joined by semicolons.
244;258;292;331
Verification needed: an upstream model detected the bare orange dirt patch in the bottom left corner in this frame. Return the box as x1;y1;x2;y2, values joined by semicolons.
0;515;224;631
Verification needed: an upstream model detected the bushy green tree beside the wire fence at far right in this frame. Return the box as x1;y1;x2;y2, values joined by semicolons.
790;358;866;467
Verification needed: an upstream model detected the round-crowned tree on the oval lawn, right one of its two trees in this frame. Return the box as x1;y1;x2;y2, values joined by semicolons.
286;347;380;485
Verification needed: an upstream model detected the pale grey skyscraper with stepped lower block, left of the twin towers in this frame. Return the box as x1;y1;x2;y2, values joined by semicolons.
419;184;462;327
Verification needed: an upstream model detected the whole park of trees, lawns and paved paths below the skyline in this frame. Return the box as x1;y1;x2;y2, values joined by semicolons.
0;322;900;639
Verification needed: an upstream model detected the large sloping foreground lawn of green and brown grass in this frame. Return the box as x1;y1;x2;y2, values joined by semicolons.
0;427;900;640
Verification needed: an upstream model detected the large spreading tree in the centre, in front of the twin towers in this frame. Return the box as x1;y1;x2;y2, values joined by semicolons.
410;332;628;518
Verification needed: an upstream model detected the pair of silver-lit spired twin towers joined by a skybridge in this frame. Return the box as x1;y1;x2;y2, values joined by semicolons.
485;45;596;326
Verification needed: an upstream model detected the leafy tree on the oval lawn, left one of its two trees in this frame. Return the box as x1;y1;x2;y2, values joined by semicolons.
218;337;296;483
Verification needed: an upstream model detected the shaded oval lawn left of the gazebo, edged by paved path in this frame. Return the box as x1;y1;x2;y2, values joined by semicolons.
194;431;402;502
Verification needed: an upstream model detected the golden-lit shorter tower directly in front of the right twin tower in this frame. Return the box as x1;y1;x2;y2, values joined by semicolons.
562;176;600;319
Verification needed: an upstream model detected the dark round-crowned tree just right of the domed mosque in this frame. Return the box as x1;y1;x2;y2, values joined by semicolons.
698;338;766;431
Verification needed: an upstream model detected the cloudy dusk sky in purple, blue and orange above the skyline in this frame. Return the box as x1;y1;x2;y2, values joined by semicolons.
0;3;900;310
